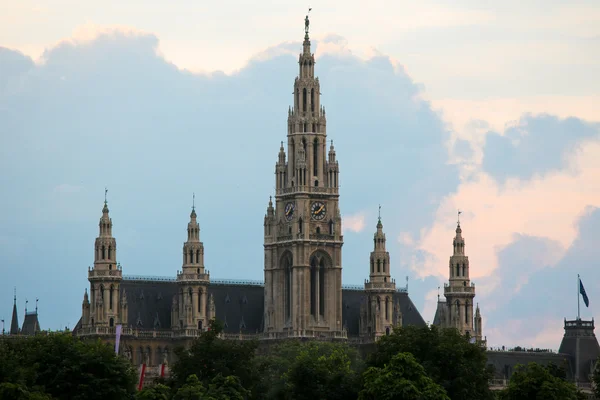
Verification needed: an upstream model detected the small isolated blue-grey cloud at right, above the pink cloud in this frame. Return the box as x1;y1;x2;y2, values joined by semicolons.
483;115;600;182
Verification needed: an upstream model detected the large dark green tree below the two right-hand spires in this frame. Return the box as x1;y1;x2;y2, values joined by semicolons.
367;326;493;400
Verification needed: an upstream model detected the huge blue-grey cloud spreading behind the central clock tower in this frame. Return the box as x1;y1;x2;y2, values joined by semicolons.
0;29;459;327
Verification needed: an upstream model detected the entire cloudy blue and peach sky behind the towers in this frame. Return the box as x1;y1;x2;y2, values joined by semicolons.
0;0;600;349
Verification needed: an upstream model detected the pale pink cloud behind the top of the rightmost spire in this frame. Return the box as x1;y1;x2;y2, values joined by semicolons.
414;134;600;279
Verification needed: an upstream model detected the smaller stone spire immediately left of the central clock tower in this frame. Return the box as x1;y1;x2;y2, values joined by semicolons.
174;194;210;330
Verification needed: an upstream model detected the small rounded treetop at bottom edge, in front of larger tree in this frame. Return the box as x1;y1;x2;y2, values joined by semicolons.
359;353;450;400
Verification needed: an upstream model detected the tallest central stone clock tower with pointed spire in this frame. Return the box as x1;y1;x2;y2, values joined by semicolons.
264;16;345;338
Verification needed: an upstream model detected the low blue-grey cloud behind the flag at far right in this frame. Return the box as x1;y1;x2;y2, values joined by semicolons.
483;207;600;349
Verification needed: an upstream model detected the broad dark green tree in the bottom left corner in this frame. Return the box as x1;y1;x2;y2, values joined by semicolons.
0;333;136;400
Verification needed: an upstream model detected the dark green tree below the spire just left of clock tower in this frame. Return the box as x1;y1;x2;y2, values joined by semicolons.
171;320;258;389
